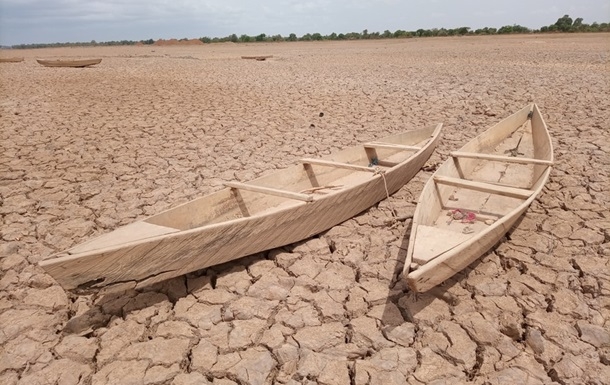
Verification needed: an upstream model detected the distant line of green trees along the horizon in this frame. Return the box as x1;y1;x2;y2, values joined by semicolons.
12;15;610;49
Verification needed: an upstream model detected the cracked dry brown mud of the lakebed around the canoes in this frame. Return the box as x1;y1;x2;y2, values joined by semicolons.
0;34;610;385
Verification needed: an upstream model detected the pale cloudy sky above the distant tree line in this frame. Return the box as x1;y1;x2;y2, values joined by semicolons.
0;0;610;45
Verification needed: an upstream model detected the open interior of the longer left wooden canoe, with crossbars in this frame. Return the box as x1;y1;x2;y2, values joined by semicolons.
146;127;436;230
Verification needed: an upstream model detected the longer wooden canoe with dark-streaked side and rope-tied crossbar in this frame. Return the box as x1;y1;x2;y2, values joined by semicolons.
40;124;442;293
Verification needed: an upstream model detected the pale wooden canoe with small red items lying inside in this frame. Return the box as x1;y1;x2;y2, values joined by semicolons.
403;104;553;292
